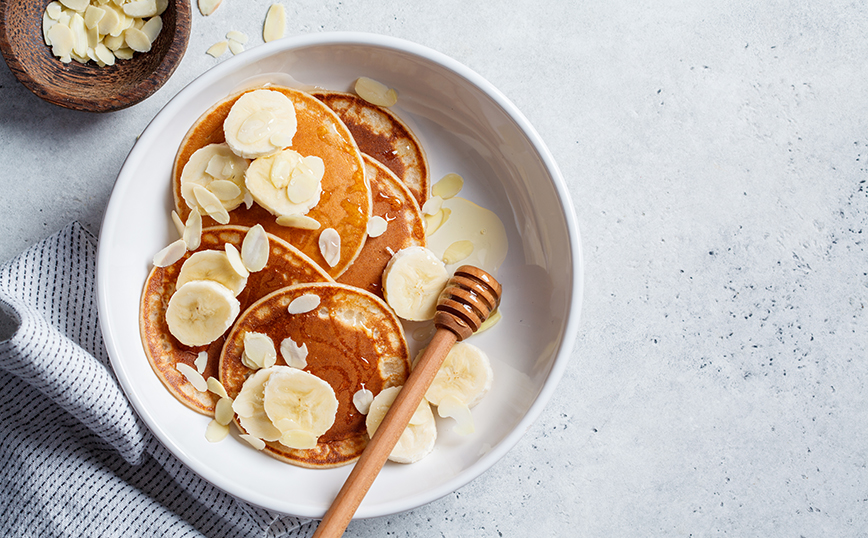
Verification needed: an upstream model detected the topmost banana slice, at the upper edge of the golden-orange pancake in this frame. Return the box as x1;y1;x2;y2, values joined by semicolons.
223;90;298;159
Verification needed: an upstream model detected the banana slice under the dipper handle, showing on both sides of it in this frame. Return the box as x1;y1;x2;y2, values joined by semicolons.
365;387;437;463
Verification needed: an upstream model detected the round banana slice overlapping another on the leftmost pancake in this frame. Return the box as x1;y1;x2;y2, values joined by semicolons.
166;280;241;346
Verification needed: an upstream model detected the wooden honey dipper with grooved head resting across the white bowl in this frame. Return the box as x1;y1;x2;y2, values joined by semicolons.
313;265;502;538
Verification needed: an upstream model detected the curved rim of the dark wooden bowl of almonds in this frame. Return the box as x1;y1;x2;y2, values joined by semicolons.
0;0;192;112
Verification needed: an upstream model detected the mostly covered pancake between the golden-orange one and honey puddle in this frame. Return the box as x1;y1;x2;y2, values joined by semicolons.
337;153;427;298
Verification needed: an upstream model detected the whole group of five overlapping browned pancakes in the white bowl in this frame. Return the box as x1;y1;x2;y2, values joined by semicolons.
140;86;429;467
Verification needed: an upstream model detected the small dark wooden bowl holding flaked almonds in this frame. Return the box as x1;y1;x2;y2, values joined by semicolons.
0;0;191;112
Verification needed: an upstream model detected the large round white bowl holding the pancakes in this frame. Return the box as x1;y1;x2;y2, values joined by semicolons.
98;33;582;518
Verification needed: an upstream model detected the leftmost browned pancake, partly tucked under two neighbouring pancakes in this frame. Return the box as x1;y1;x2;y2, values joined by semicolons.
139;226;331;415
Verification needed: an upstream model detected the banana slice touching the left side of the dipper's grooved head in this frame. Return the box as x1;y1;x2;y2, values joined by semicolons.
383;246;449;321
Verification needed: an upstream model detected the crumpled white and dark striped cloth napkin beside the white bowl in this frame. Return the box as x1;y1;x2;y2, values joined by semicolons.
0;222;315;538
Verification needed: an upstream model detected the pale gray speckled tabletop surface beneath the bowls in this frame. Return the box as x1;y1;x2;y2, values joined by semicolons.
0;0;868;537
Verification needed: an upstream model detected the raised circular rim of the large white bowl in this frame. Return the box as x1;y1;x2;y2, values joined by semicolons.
98;31;584;519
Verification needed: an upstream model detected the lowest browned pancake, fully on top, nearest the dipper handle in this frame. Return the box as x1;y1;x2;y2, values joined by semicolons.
220;284;410;468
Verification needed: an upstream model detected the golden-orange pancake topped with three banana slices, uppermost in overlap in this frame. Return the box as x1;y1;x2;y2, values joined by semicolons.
172;86;371;277
